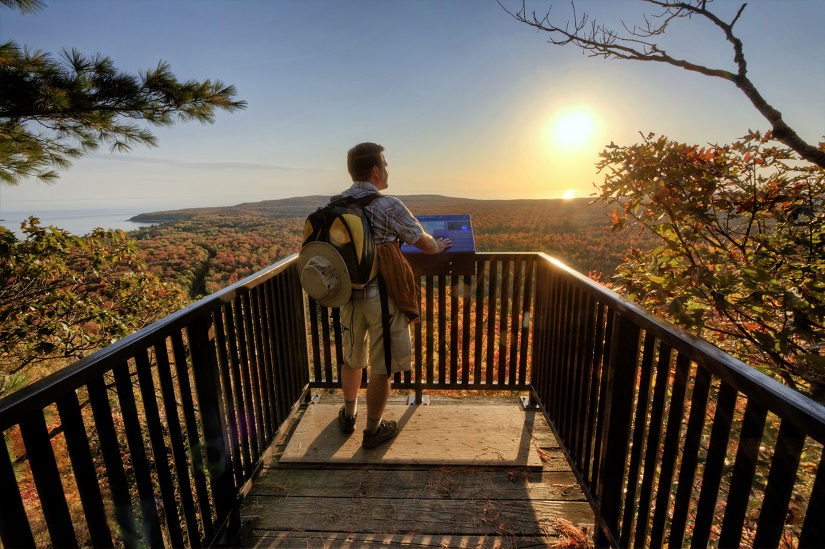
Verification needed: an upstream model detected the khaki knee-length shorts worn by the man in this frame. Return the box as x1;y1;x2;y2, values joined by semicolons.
341;296;412;374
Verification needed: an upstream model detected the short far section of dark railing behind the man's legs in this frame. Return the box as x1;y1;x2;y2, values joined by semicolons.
309;253;536;402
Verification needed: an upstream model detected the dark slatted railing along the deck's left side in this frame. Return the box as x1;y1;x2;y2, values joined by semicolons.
0;257;308;547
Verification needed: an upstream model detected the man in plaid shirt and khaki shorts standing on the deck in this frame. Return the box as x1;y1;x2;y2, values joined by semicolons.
338;143;452;448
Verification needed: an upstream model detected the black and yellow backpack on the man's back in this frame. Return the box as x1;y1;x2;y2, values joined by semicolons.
303;193;381;290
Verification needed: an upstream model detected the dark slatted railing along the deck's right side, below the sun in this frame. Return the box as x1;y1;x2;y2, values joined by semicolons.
531;256;825;547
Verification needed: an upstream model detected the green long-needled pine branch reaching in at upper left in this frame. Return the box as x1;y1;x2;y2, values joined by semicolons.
0;42;246;185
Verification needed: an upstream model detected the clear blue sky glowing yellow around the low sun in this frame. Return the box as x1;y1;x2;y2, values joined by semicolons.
0;0;825;213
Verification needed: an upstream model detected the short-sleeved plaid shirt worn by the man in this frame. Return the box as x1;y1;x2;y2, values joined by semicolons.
333;181;424;246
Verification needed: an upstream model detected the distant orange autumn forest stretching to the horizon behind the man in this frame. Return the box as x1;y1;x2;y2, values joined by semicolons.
130;195;655;299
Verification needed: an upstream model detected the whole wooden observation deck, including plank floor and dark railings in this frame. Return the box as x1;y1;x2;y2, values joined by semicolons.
0;253;825;548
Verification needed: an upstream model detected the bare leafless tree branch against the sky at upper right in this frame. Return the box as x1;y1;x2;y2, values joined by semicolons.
498;0;825;168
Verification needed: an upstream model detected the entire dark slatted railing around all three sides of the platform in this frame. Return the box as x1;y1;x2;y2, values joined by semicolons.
0;250;825;547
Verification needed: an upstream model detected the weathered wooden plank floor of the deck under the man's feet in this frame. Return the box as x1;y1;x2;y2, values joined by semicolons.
241;395;594;548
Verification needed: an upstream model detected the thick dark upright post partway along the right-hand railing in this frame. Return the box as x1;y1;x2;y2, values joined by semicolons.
596;313;640;543
